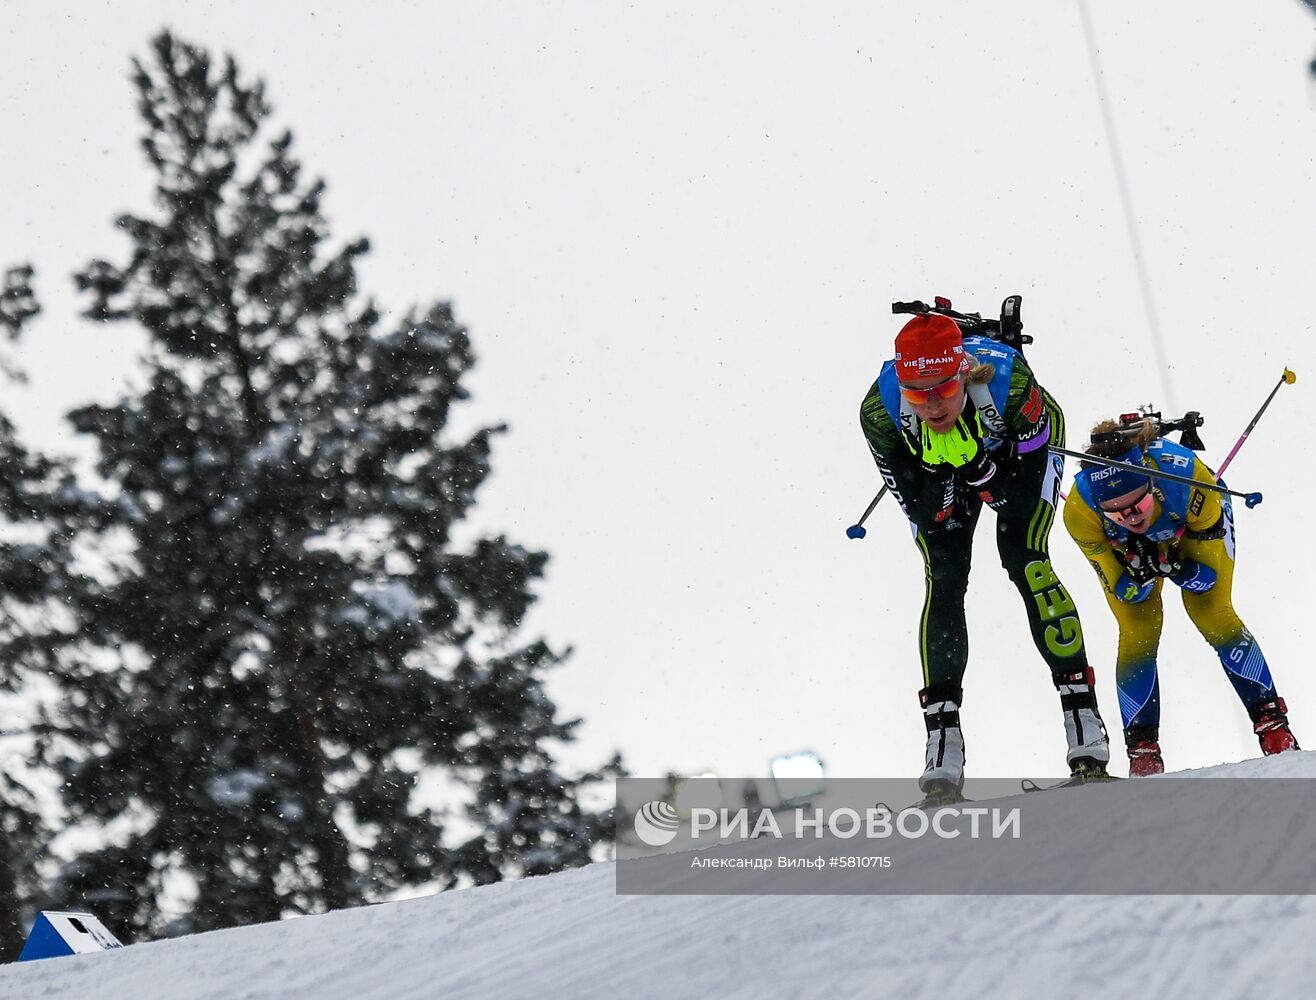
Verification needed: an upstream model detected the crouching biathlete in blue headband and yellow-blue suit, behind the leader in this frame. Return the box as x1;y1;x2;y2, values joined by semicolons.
1065;421;1298;776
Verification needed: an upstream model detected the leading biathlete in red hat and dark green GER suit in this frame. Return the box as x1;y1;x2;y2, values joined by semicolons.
859;313;1111;801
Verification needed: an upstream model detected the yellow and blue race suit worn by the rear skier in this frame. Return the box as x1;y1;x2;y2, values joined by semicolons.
1065;439;1275;730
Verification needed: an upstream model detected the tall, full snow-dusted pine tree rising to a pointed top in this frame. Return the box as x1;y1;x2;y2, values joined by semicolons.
41;33;612;933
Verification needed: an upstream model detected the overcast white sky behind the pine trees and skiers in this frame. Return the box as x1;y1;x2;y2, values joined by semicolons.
0;0;1316;776
